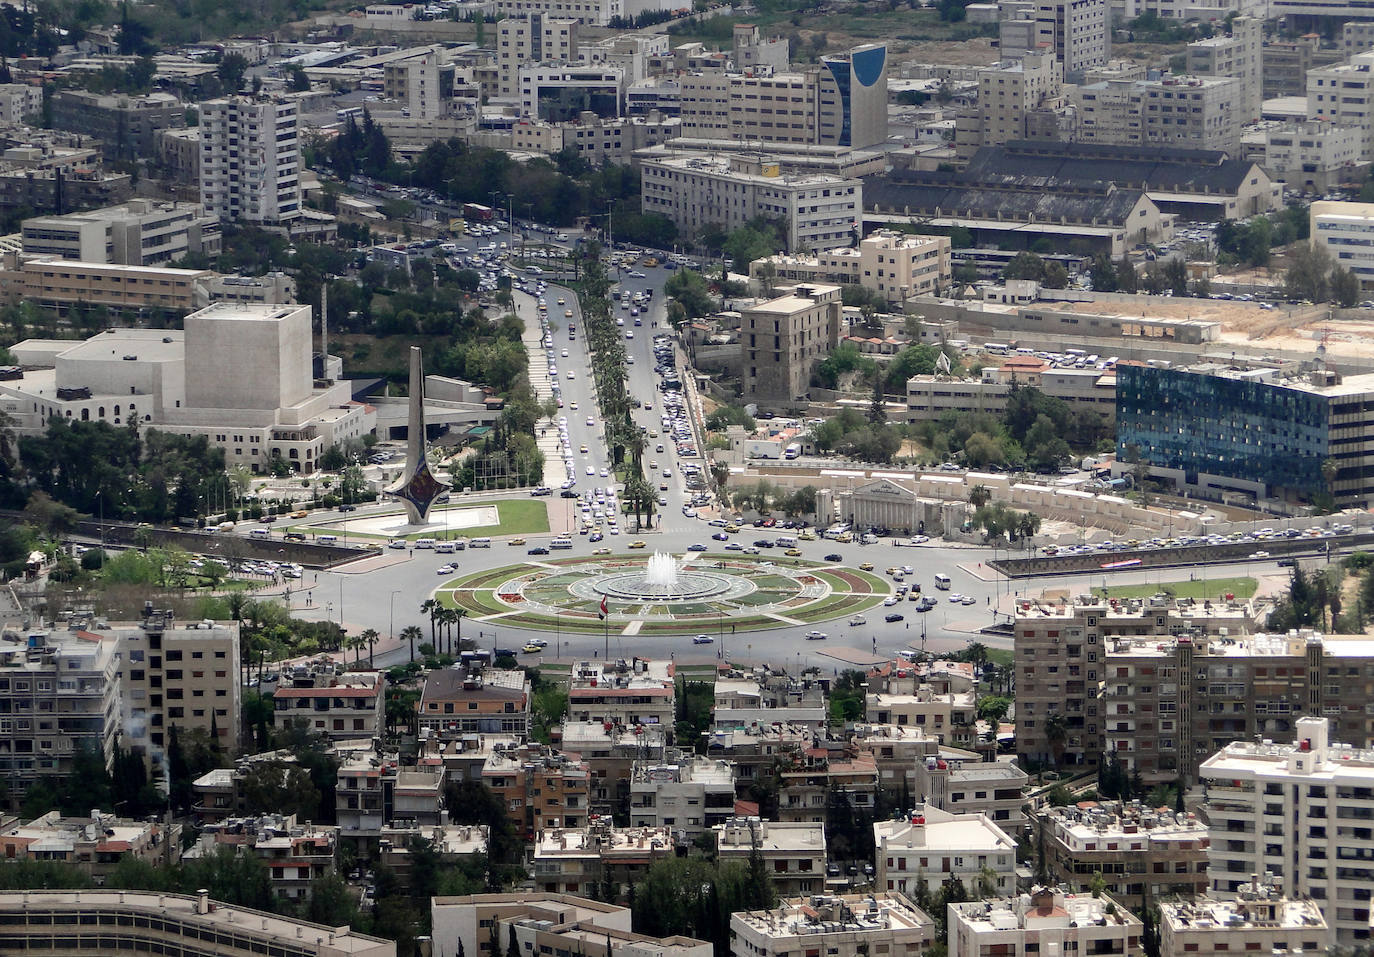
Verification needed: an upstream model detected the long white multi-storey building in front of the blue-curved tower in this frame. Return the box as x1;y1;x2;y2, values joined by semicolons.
640;151;863;250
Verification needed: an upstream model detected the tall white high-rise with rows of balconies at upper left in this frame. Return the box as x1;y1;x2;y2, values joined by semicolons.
201;96;301;227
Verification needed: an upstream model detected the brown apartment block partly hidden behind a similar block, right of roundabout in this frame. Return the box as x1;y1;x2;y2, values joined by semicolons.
1014;596;1257;766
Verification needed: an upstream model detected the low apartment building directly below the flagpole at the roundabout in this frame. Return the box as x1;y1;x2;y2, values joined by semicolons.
567;658;676;729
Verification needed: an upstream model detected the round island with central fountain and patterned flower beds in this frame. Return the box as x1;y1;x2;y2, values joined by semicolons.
436;552;890;636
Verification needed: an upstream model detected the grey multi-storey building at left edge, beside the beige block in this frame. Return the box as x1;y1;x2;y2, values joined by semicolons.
0;629;122;791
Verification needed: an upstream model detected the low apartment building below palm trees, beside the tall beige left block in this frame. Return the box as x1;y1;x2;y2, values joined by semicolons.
272;671;386;741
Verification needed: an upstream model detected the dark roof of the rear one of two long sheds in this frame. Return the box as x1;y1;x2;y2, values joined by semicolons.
963;140;1254;195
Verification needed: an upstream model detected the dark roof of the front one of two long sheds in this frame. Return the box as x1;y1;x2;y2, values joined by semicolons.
863;170;1145;227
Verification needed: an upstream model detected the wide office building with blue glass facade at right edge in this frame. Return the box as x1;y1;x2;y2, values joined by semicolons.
1117;356;1374;508
